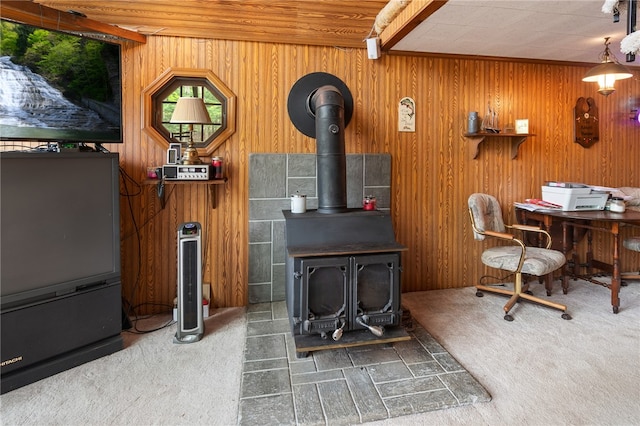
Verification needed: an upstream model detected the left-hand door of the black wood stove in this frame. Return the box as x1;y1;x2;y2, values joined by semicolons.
300;257;349;334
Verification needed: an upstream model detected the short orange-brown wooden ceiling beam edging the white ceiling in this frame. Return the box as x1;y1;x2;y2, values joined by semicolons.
380;0;448;51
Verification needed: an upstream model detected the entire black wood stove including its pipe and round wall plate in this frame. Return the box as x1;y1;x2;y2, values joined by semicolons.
283;73;409;355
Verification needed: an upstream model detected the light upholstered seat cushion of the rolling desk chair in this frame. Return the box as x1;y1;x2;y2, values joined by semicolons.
481;246;566;276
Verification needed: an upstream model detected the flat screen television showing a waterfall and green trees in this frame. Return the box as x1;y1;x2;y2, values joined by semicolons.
0;20;122;144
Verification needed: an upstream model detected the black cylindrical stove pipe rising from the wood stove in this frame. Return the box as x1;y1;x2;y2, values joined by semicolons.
307;85;347;213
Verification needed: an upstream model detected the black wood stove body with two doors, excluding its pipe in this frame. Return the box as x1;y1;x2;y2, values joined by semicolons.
283;209;406;356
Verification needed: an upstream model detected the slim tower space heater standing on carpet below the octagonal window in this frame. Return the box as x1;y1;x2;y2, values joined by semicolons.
173;222;204;343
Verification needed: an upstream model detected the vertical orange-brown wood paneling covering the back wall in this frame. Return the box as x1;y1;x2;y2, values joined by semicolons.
104;36;640;307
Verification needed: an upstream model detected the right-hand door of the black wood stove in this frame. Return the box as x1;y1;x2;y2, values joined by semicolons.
350;253;402;330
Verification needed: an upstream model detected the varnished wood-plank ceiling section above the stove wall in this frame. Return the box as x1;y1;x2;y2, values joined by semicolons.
36;0;387;48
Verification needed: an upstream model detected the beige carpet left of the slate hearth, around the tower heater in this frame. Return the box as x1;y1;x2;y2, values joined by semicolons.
0;308;246;426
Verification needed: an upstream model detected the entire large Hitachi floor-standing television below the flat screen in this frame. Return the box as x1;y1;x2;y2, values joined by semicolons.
0;151;123;393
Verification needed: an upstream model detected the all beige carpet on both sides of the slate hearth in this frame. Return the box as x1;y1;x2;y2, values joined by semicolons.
0;282;640;425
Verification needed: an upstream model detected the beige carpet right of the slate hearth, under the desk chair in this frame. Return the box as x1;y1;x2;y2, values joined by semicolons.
370;281;640;426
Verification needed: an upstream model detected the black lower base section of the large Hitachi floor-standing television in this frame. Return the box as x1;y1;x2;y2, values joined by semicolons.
0;282;123;393
